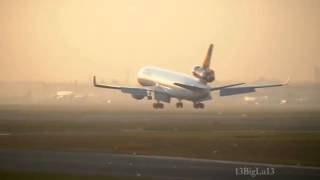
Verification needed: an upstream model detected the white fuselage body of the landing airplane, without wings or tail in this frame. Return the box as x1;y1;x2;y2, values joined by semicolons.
138;67;211;101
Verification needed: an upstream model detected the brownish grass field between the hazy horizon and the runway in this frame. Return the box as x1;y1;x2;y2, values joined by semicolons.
0;106;320;166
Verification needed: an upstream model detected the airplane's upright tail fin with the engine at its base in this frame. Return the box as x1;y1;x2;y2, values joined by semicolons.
192;44;215;83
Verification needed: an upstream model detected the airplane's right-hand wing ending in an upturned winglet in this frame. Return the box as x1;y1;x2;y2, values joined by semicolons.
220;79;289;96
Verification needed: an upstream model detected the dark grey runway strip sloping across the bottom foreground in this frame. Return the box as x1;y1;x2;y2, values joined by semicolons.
0;149;320;180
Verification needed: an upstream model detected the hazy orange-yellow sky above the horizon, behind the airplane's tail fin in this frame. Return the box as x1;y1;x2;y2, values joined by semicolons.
0;0;320;82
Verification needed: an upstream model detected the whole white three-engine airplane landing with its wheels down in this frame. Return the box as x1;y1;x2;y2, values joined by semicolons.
93;44;289;109
